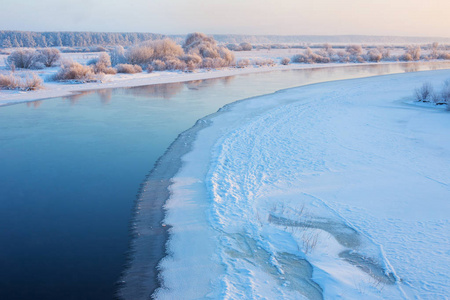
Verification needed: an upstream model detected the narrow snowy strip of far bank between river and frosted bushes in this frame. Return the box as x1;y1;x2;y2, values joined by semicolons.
0;62;439;107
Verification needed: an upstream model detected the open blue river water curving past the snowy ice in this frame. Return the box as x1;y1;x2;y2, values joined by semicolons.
0;63;450;299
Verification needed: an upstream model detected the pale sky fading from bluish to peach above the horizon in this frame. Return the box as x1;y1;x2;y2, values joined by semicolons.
0;0;450;37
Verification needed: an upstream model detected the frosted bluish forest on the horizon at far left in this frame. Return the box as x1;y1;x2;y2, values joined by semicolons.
0;31;164;48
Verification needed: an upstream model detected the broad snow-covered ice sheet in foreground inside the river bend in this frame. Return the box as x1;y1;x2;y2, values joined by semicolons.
120;71;450;299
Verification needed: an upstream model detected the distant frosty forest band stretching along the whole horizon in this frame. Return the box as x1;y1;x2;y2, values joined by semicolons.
0;30;450;48
